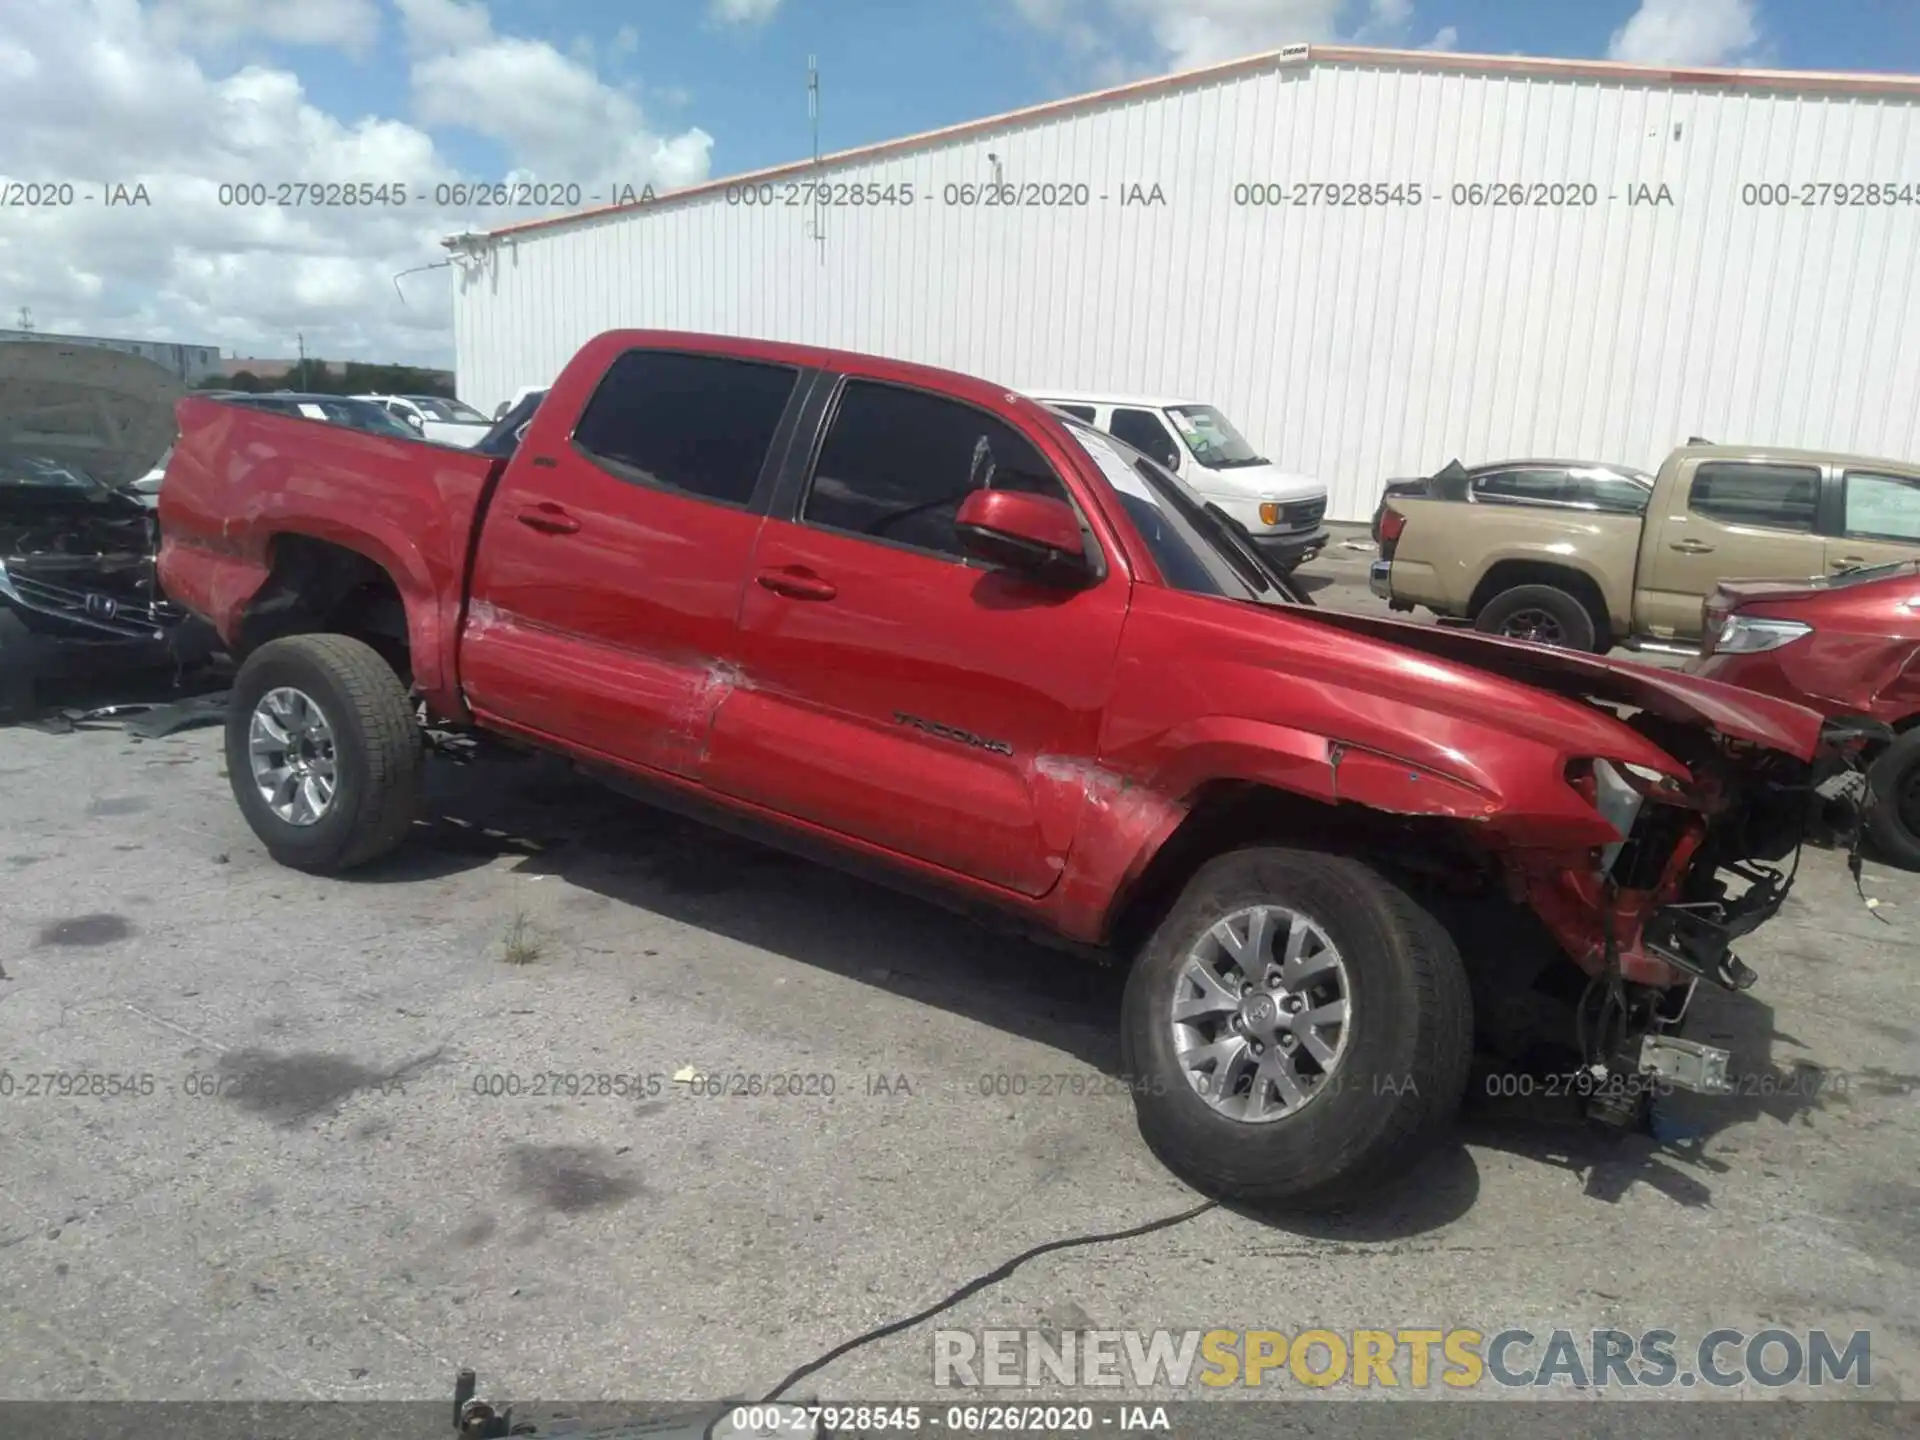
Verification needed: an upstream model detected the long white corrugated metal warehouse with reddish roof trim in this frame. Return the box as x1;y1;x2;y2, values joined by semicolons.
447;44;1920;520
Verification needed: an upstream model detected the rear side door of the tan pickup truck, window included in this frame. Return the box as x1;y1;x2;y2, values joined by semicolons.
1634;461;1826;639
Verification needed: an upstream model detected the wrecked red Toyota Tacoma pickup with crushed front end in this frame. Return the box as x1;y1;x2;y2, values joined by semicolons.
159;330;1858;1208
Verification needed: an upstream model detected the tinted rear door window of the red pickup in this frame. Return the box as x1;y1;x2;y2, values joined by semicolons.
574;349;799;505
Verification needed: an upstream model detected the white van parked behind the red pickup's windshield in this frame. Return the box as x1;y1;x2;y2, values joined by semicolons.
1025;390;1327;570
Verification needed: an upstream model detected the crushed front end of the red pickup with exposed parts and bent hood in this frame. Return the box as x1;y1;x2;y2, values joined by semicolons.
1297;616;1887;1129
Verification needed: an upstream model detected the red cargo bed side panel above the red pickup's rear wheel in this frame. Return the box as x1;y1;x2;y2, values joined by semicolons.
159;396;503;714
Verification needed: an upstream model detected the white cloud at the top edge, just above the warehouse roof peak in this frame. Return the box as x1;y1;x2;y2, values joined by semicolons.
1012;0;1459;69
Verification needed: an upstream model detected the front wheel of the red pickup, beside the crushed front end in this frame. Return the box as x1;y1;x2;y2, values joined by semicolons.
1121;849;1473;1210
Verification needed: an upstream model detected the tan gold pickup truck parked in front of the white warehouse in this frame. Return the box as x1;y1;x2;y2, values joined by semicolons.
1369;444;1920;655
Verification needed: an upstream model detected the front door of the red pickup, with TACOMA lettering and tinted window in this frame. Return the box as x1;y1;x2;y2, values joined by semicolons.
708;378;1127;895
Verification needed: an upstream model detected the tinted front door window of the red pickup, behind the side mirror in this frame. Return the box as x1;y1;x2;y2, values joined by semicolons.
801;380;1071;557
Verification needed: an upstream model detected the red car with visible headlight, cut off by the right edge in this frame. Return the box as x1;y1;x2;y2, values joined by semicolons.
1688;561;1920;870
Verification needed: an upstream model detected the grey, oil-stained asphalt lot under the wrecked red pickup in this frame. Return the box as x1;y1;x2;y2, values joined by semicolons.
0;526;1920;1400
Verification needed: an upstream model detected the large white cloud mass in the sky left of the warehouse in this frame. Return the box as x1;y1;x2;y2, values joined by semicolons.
0;0;712;365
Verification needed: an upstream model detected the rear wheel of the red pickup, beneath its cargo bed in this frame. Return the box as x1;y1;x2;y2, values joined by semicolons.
227;636;426;874
